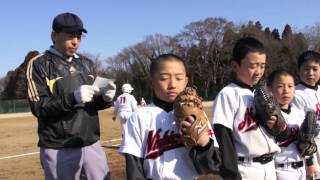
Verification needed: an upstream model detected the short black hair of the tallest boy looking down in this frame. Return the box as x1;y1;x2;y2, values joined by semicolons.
232;37;266;64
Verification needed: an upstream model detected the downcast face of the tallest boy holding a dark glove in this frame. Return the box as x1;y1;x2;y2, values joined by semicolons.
231;53;266;86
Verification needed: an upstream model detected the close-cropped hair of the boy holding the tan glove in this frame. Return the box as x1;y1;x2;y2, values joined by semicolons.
149;53;186;78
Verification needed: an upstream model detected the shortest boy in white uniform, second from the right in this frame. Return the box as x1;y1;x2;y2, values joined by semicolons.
267;69;312;180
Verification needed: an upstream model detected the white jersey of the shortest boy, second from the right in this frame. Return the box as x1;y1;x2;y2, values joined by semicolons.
275;106;305;163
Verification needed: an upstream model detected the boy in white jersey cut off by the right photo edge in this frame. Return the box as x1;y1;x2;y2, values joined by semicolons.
294;51;320;179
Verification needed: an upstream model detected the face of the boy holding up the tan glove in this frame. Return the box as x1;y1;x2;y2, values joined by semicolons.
151;59;188;103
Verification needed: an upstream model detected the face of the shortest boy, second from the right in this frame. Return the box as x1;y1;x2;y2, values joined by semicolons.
271;75;295;109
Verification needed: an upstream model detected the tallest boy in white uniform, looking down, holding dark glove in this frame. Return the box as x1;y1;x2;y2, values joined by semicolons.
212;37;280;180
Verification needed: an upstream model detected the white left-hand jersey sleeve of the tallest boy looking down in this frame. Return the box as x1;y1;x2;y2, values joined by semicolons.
211;90;236;130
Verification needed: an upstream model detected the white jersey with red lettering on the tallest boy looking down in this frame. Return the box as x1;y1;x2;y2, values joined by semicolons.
211;83;280;157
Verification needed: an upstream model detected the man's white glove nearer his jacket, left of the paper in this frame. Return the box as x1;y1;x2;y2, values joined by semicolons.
73;85;99;103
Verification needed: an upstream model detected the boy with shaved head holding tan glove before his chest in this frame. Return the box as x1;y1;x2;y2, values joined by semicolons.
119;54;218;180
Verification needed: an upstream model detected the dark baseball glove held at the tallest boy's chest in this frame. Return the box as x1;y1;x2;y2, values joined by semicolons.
254;83;287;137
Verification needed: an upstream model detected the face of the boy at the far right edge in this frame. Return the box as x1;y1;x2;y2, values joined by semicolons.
299;60;320;86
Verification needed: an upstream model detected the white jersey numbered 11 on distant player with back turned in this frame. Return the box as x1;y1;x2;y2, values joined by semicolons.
114;93;138;128
